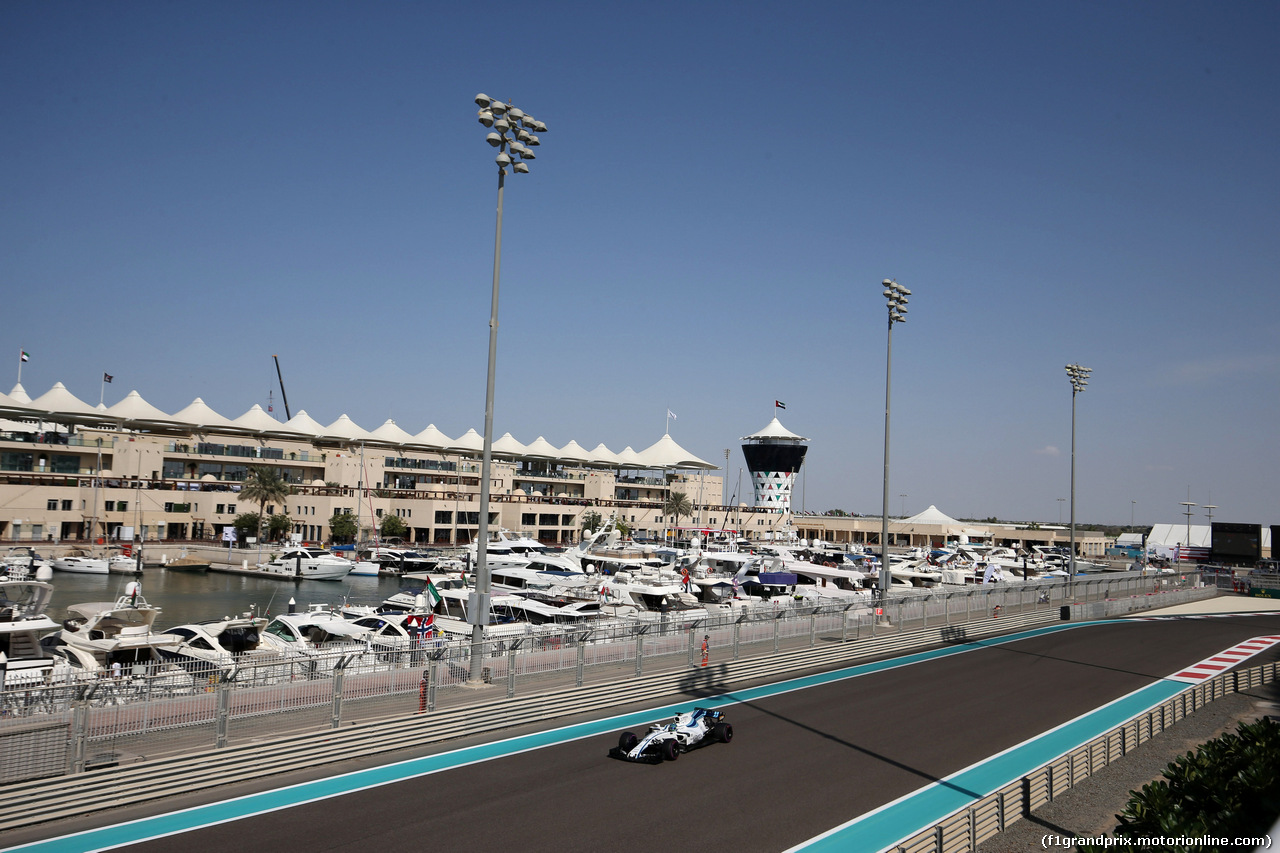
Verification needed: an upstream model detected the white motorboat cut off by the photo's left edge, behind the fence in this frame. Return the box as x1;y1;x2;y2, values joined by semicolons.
0;580;72;692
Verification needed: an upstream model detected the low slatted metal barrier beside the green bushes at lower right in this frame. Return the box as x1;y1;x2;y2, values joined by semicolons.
891;661;1280;853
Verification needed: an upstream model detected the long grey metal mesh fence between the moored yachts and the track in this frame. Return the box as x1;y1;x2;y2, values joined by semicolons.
0;574;1199;781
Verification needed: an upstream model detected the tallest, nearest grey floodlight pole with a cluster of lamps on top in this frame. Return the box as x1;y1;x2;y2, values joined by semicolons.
467;93;547;684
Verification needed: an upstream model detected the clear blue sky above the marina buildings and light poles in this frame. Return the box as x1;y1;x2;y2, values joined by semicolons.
0;0;1280;524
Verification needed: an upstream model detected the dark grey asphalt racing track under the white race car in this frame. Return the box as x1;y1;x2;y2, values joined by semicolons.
10;615;1280;853
